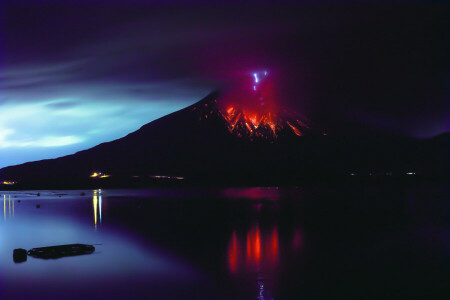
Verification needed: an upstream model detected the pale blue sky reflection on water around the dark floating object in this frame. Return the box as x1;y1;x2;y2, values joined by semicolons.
0;190;207;299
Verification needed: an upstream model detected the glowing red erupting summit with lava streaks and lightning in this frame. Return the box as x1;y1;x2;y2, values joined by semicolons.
193;71;326;140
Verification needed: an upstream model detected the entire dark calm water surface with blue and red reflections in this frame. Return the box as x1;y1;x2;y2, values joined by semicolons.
0;186;450;300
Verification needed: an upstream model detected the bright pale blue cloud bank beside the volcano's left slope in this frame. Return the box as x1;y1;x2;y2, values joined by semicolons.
0;61;209;167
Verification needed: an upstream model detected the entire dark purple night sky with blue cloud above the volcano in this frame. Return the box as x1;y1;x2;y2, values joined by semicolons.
0;0;450;167
